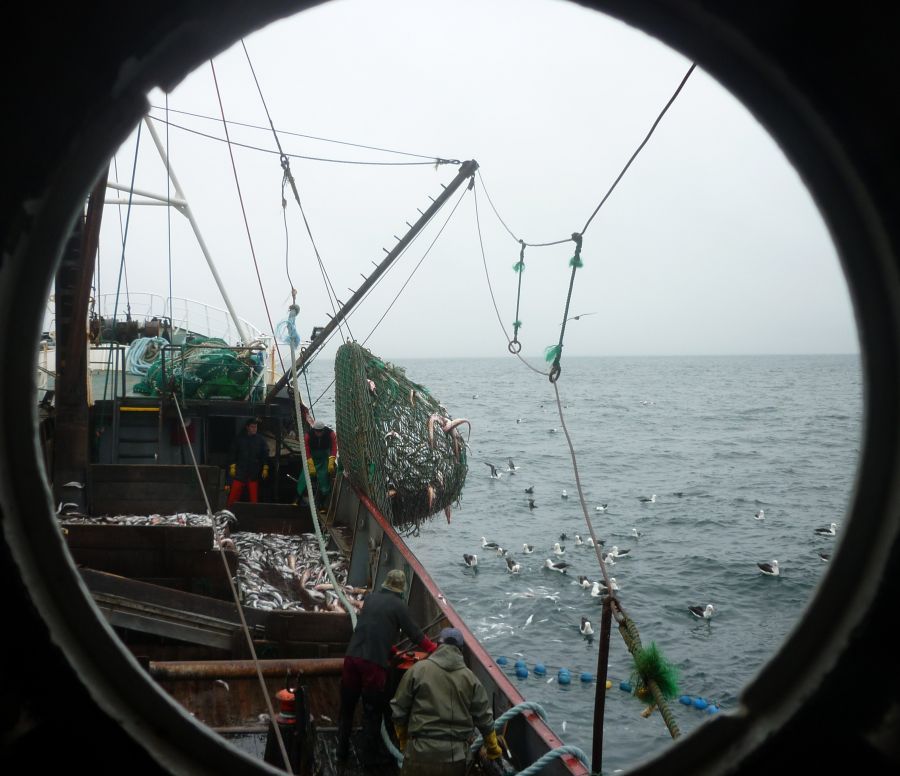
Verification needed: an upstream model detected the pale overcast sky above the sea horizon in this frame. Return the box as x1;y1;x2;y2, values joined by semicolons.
91;0;858;359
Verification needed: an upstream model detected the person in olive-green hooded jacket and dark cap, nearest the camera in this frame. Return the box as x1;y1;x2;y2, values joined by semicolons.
391;628;503;776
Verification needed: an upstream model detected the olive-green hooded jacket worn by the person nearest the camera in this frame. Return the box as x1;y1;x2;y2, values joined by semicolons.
391;644;494;762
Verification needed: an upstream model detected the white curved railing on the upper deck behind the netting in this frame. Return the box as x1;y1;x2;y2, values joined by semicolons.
94;292;272;347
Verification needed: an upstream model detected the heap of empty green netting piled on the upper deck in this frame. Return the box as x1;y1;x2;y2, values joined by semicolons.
134;337;263;401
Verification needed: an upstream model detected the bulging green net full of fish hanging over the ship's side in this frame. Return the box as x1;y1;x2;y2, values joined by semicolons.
334;343;469;528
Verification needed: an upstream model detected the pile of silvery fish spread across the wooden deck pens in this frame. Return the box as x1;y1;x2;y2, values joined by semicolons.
59;509;366;614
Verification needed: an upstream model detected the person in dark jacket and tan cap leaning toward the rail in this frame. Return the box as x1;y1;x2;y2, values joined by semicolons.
338;569;437;767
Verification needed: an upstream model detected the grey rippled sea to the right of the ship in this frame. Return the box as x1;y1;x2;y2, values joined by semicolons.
326;354;863;773
